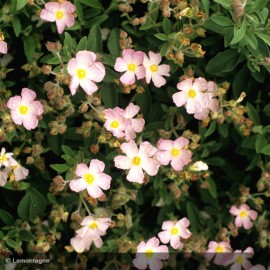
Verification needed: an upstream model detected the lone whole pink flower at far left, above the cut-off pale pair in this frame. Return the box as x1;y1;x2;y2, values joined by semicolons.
7;88;43;130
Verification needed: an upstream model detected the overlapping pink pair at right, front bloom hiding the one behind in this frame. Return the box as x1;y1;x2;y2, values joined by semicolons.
173;77;219;120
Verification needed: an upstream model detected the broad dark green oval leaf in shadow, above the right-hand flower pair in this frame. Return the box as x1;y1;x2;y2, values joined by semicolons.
206;49;240;76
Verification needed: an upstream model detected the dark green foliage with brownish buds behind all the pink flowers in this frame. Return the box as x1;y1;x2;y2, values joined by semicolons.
0;0;270;269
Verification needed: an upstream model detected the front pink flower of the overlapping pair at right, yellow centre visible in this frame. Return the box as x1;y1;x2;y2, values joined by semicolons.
172;78;209;114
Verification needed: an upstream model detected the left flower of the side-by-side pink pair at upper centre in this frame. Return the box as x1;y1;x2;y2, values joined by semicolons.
114;49;145;85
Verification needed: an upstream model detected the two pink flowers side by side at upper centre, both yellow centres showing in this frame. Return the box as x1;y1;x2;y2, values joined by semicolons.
114;49;170;87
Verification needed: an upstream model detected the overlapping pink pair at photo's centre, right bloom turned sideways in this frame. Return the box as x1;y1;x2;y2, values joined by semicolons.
103;103;145;141
